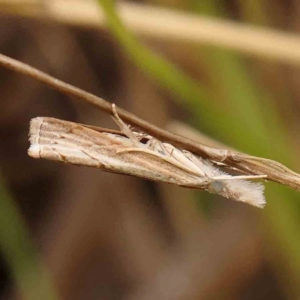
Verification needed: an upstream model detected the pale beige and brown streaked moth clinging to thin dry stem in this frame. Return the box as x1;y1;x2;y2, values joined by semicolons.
28;104;266;207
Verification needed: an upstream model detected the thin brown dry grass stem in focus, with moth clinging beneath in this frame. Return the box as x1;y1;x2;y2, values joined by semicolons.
0;54;300;190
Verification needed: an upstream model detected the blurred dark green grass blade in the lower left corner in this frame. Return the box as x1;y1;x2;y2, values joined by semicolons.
0;173;58;300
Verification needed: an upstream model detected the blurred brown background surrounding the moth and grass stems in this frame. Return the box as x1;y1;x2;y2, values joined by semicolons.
0;0;300;300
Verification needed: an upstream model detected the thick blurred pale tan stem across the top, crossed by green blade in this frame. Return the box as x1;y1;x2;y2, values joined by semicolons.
0;0;300;65
